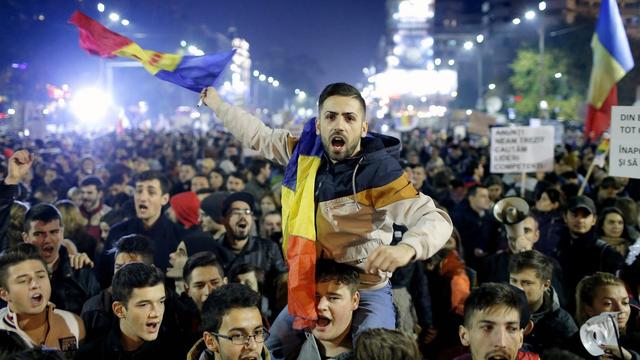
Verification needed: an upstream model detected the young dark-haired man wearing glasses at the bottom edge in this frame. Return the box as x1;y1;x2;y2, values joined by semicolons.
187;283;271;360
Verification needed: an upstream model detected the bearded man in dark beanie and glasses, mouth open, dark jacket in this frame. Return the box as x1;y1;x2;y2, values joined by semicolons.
217;192;287;296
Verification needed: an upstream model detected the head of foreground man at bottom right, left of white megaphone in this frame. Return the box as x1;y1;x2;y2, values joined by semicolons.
456;283;524;360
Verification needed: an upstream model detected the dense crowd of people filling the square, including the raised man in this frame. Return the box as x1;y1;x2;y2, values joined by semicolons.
0;83;640;360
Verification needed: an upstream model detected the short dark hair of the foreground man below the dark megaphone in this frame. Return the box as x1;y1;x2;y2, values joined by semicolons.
464;283;521;328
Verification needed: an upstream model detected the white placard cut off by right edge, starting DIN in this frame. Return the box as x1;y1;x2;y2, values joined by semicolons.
609;106;640;178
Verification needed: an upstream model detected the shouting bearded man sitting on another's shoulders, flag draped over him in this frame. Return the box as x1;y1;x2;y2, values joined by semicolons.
202;83;452;358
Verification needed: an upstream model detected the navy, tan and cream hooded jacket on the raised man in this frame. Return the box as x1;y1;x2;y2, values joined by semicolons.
214;103;452;288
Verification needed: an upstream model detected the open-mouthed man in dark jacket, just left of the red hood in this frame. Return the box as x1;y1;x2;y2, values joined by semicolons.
98;170;182;288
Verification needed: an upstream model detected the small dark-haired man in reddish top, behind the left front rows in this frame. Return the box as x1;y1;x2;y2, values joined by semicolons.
80;176;111;241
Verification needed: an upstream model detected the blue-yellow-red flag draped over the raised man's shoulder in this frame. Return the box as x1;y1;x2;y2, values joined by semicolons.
282;118;323;329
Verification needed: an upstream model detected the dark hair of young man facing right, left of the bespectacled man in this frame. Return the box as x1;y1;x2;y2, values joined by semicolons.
111;263;164;307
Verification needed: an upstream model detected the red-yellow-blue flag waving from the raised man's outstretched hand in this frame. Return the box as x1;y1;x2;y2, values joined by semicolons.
69;11;235;92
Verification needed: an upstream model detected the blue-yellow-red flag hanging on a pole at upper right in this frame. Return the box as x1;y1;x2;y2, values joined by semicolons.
584;0;634;141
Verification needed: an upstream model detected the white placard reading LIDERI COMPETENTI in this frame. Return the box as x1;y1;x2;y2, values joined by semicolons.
490;126;554;174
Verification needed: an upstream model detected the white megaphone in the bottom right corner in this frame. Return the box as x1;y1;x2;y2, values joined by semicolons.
580;312;620;356
